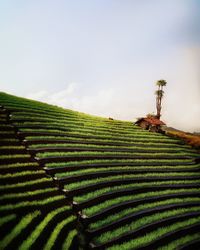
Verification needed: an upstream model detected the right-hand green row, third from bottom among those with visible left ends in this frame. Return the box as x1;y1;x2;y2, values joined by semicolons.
83;188;200;216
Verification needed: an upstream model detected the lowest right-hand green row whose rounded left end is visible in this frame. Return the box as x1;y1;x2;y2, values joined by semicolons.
95;207;200;243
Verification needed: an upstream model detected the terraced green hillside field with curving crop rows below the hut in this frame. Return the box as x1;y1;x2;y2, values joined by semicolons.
0;93;200;250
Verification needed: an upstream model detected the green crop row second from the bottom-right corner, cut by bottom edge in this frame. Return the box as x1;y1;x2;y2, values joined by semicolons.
107;216;200;250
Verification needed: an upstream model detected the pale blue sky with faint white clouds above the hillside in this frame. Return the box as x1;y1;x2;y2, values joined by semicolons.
0;0;200;132
